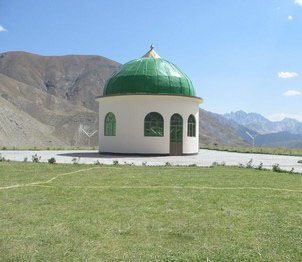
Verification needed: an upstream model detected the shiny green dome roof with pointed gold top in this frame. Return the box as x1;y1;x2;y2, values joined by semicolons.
103;47;196;96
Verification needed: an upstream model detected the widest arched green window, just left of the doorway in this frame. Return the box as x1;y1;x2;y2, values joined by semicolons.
144;112;164;136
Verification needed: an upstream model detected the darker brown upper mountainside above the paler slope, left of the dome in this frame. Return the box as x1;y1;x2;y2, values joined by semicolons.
0;52;120;111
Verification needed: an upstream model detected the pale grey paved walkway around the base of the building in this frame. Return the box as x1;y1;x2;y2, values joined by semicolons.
0;149;302;173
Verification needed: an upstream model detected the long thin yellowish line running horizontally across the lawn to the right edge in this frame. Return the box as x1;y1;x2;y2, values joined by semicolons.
28;184;302;193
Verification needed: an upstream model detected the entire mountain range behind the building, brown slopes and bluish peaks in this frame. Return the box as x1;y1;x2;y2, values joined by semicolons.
0;52;302;148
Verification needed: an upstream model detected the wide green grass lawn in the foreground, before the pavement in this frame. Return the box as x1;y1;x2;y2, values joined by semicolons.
0;162;302;261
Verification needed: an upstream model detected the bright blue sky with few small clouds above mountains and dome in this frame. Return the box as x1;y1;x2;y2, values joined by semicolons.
0;0;302;121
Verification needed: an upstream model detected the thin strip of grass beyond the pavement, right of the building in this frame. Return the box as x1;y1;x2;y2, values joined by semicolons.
201;145;302;156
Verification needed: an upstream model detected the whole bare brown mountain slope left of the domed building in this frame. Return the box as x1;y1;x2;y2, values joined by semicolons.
0;52;120;147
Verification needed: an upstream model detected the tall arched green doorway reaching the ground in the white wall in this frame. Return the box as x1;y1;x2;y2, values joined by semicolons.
170;114;183;156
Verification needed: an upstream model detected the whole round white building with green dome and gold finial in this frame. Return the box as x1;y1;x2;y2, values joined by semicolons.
97;46;202;155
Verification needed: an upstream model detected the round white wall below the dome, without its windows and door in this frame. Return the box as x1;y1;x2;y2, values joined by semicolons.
98;95;201;154
